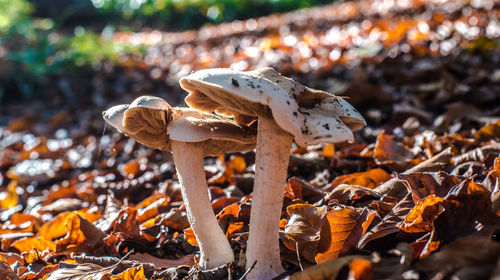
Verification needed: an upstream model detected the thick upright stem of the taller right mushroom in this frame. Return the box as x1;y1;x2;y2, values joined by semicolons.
246;117;292;280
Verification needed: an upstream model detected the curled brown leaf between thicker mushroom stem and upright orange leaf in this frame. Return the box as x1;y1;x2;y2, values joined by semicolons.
284;204;327;263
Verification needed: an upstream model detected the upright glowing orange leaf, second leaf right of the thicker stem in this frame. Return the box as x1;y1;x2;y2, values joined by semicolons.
316;208;375;263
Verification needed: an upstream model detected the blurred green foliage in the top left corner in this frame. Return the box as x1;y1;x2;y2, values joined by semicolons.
0;0;142;102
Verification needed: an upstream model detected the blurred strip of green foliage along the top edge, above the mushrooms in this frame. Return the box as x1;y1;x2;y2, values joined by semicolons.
92;0;333;29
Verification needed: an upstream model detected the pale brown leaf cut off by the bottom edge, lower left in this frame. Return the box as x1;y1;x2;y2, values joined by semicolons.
45;262;115;280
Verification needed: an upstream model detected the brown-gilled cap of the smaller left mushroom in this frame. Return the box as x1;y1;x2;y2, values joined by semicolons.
103;96;256;155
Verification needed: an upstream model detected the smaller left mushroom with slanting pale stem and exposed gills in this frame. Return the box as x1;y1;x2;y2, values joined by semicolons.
103;96;255;269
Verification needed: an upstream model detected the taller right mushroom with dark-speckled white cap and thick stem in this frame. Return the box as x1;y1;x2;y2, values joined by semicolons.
180;68;366;279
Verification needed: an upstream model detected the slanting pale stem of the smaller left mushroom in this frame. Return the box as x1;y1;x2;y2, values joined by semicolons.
172;141;234;269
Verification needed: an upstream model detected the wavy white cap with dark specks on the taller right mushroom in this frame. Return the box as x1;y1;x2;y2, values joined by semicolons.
180;68;366;146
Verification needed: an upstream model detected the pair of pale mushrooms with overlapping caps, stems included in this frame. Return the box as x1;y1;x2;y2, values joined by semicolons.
103;68;366;279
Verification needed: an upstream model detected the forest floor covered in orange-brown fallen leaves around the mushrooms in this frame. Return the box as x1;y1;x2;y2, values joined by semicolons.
0;0;500;279
